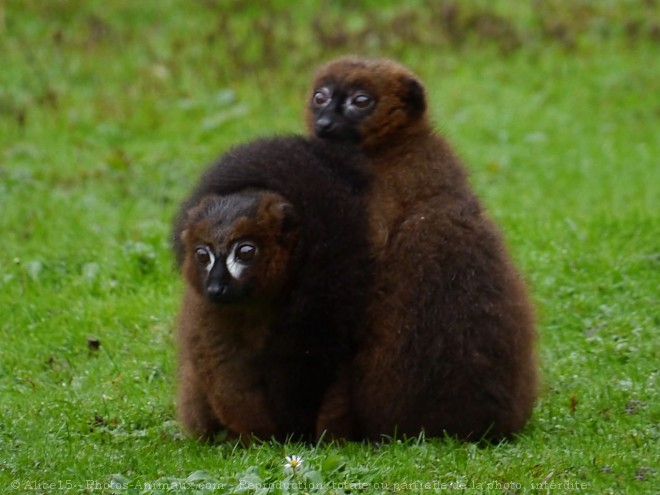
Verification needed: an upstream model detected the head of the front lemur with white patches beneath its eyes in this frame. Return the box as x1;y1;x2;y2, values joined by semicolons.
182;192;298;303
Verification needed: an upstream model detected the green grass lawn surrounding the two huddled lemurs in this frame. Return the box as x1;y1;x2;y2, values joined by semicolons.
0;0;660;494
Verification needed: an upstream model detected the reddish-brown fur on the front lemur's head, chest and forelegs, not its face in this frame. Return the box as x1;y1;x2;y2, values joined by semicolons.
178;193;296;439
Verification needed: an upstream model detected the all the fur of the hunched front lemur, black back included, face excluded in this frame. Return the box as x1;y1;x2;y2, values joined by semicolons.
173;138;371;439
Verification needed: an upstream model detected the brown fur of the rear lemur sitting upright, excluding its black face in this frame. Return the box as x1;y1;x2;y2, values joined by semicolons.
306;57;537;440
